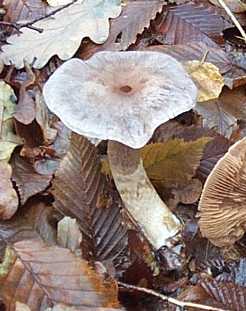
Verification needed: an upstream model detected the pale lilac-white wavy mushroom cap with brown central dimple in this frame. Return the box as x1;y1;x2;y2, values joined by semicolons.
43;51;197;148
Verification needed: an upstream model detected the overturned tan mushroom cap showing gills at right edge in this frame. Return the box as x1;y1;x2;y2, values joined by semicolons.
198;138;246;247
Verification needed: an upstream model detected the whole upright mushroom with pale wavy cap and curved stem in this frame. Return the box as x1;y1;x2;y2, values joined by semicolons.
43;51;197;249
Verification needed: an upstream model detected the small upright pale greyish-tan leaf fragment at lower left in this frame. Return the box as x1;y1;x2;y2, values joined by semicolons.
57;216;82;252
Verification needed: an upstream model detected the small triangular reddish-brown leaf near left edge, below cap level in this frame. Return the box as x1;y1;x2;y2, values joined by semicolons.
11;153;52;205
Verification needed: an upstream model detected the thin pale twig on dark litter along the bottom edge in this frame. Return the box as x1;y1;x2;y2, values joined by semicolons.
118;281;230;311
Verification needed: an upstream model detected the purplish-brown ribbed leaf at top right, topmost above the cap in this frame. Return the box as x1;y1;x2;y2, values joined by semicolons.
156;2;227;47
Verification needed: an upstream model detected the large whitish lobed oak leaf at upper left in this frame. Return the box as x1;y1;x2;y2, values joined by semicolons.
0;0;121;68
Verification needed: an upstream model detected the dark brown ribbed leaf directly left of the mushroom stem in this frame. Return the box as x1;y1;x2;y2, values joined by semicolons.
52;134;128;272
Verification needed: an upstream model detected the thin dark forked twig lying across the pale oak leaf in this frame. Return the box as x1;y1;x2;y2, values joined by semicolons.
0;0;78;33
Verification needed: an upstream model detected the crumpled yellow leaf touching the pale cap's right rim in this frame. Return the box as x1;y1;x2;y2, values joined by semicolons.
185;60;224;102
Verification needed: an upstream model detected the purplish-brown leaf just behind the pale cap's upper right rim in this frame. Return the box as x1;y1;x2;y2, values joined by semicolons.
148;41;232;73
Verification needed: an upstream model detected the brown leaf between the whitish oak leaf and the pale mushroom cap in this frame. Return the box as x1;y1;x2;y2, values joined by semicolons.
80;0;165;58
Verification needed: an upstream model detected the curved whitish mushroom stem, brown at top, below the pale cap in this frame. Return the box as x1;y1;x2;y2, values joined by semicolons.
108;141;181;250
